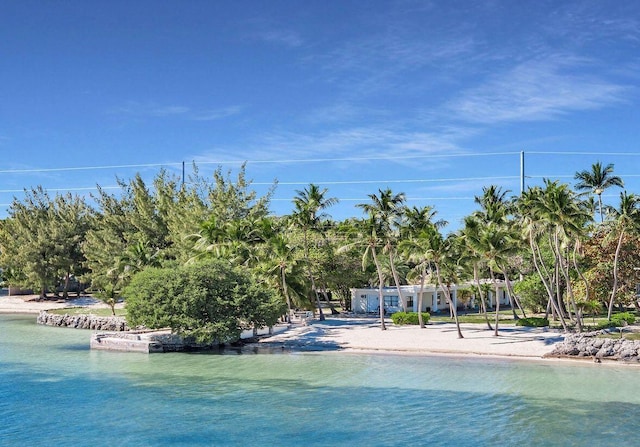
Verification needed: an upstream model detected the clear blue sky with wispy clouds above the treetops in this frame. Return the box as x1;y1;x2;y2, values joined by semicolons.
0;0;640;229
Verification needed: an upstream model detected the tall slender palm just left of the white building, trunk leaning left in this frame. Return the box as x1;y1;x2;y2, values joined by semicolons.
293;183;338;321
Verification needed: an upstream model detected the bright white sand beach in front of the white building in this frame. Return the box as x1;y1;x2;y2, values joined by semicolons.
259;318;564;359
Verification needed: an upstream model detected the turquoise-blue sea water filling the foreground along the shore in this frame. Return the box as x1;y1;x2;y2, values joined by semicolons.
0;315;640;446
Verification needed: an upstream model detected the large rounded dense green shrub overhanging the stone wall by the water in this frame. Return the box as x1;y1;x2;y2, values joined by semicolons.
123;260;286;343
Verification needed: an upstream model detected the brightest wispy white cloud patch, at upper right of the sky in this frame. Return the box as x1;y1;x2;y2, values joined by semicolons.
445;57;629;124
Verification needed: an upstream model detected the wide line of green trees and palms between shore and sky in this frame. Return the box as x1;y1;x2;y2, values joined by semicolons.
0;162;640;337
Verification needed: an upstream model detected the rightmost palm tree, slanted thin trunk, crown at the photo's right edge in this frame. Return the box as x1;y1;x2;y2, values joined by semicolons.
607;191;640;320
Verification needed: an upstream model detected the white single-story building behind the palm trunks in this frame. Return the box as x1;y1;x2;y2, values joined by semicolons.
351;280;510;314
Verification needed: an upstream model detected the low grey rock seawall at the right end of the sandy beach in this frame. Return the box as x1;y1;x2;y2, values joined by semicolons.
545;331;640;362
